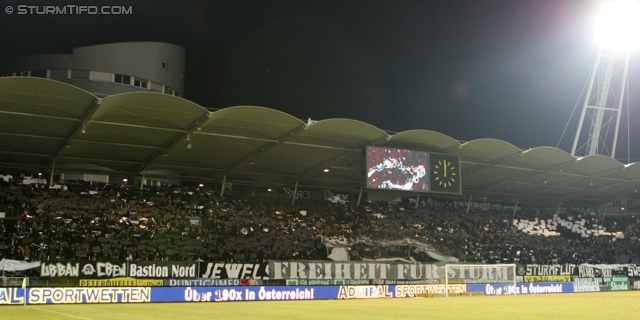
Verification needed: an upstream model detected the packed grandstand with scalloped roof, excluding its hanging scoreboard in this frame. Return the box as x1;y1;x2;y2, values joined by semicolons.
0;77;640;272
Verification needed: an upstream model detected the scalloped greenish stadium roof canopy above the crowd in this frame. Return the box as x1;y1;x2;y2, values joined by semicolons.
0;77;640;203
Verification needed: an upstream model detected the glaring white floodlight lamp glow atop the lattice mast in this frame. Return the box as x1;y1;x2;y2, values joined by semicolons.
595;0;640;51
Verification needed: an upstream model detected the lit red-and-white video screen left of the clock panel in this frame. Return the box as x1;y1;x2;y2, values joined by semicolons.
367;146;429;192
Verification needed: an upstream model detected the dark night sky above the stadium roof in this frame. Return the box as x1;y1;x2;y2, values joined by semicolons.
0;0;640;162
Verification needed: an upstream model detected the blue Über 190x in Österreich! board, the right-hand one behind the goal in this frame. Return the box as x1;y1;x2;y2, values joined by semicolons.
467;282;573;296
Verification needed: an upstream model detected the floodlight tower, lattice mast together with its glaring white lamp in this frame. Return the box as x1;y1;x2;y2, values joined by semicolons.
571;0;640;158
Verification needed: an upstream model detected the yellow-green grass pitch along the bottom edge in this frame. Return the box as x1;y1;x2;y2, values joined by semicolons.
0;291;640;320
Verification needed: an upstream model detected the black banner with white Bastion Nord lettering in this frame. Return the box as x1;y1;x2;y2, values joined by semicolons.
128;261;196;278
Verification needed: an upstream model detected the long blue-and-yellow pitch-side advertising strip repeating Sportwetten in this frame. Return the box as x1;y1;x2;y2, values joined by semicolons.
0;282;592;304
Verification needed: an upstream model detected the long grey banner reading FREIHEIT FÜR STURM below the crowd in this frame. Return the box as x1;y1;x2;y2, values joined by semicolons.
269;260;515;283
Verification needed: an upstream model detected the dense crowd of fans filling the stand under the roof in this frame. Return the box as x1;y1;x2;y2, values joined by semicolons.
0;180;640;264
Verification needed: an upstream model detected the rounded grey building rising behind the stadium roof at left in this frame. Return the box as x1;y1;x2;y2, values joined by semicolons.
0;42;185;98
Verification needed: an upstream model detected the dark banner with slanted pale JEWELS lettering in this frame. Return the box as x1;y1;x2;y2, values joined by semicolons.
199;262;269;280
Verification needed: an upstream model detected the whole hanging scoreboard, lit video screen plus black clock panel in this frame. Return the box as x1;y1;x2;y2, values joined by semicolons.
366;146;462;194
